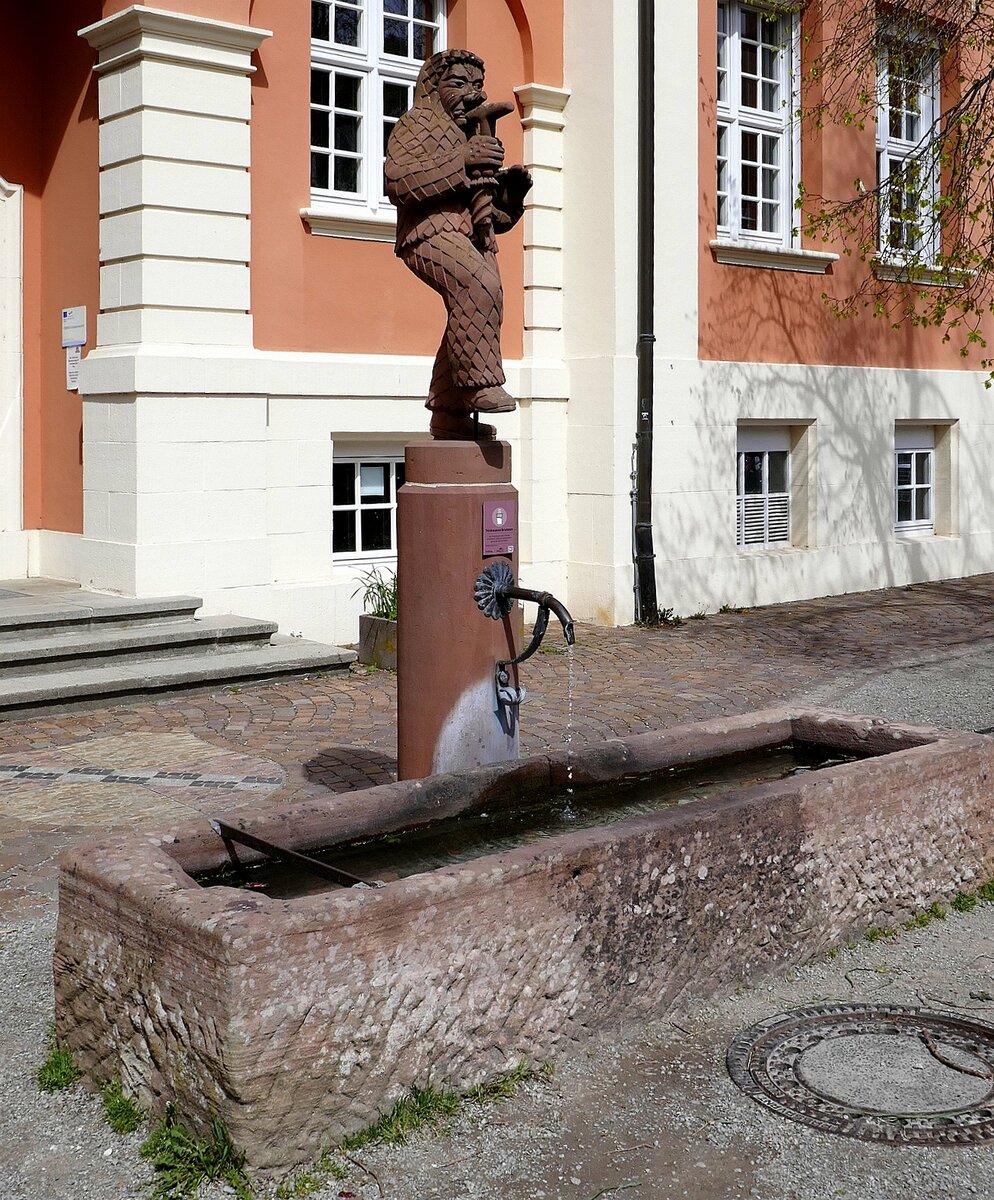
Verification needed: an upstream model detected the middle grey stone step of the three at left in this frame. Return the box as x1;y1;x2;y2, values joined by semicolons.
0;617;277;679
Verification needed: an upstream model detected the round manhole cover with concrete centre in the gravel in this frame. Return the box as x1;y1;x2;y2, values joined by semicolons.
727;1004;994;1146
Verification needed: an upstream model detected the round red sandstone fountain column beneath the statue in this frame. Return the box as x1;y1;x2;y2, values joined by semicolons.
397;440;517;779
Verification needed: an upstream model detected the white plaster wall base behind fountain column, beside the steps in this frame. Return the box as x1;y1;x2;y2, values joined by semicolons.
75;346;567;643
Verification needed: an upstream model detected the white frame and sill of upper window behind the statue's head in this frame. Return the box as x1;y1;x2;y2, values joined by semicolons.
301;0;448;241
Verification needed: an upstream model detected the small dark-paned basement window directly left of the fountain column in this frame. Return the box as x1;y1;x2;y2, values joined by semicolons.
331;455;403;558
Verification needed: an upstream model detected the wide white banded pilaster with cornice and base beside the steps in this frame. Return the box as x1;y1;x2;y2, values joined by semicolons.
78;5;270;609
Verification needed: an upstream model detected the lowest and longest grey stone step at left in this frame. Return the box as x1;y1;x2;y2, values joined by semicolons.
0;635;355;718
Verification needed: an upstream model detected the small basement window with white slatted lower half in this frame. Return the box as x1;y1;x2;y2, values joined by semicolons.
735;427;791;550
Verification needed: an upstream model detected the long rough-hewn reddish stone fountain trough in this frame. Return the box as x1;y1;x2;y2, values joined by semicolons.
55;709;994;1174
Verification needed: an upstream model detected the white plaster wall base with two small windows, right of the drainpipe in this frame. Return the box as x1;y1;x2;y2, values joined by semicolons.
653;361;994;616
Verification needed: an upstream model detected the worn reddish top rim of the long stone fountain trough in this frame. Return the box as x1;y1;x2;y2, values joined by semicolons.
59;707;969;926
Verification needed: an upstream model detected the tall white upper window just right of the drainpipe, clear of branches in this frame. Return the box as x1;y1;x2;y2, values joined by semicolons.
717;0;797;247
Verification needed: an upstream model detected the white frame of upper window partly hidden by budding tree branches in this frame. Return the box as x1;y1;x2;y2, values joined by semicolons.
876;40;941;266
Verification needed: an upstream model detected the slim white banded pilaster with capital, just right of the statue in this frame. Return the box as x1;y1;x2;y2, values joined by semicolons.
514;83;570;360
